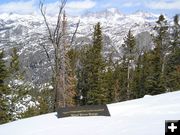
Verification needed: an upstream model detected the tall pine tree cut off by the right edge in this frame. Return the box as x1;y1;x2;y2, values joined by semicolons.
165;15;180;91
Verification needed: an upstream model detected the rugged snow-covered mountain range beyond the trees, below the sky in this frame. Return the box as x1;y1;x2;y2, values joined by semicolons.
0;8;158;84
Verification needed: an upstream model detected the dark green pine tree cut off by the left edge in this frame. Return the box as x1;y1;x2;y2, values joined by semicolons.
0;50;9;124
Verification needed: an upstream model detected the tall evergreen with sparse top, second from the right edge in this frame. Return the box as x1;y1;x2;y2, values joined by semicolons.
145;15;170;95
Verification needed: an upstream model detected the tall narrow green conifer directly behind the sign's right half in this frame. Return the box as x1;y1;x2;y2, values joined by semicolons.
87;23;107;104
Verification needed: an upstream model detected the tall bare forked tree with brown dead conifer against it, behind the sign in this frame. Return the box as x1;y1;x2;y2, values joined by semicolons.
40;0;80;110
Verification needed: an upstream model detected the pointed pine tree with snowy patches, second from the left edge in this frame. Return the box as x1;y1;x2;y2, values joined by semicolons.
8;48;28;121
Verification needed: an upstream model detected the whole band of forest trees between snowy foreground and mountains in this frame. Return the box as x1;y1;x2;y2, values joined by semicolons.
0;4;180;124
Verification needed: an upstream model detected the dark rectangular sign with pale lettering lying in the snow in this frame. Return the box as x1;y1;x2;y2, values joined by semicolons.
57;105;110;118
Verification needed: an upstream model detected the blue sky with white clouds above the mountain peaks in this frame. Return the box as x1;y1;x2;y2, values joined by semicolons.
0;0;180;17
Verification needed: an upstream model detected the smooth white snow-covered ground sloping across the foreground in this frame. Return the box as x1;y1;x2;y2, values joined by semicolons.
0;91;180;135
